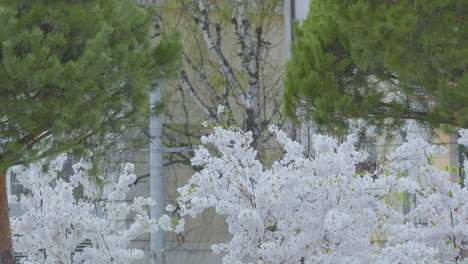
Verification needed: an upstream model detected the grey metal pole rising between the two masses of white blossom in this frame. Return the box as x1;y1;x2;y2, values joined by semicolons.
149;86;165;264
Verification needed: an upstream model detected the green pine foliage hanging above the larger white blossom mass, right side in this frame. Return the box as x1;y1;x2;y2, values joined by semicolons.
284;0;468;135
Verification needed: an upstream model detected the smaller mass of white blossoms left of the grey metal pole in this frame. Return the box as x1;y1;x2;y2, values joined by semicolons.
11;155;183;264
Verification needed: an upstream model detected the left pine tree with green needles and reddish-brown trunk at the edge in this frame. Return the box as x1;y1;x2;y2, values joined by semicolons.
0;0;180;264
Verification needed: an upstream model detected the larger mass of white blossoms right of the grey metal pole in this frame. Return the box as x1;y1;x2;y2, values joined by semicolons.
178;127;468;264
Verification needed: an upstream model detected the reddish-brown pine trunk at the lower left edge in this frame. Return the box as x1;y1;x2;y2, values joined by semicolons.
0;172;15;264
